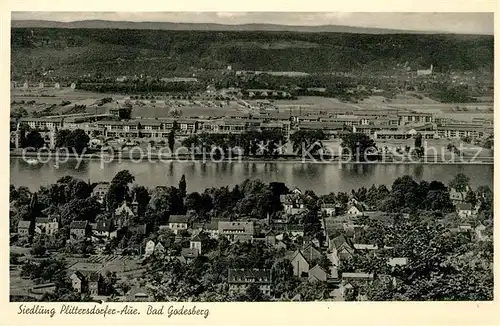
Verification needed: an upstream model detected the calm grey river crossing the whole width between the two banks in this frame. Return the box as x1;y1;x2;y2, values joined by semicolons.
10;157;493;194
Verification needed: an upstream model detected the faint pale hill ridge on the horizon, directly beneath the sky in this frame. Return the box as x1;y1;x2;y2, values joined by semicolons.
11;20;450;34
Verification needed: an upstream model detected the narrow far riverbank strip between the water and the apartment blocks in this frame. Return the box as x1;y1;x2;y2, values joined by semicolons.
10;150;494;165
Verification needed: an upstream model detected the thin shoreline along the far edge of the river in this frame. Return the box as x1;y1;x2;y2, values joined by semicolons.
9;151;494;165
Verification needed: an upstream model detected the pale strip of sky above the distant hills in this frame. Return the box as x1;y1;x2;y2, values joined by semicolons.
12;11;494;35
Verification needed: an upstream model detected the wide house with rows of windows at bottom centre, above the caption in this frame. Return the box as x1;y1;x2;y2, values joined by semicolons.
228;268;271;296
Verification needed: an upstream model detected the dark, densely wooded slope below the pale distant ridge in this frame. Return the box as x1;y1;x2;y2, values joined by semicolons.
11;28;493;77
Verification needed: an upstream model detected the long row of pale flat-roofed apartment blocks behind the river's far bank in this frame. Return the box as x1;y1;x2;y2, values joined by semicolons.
15;112;493;139
